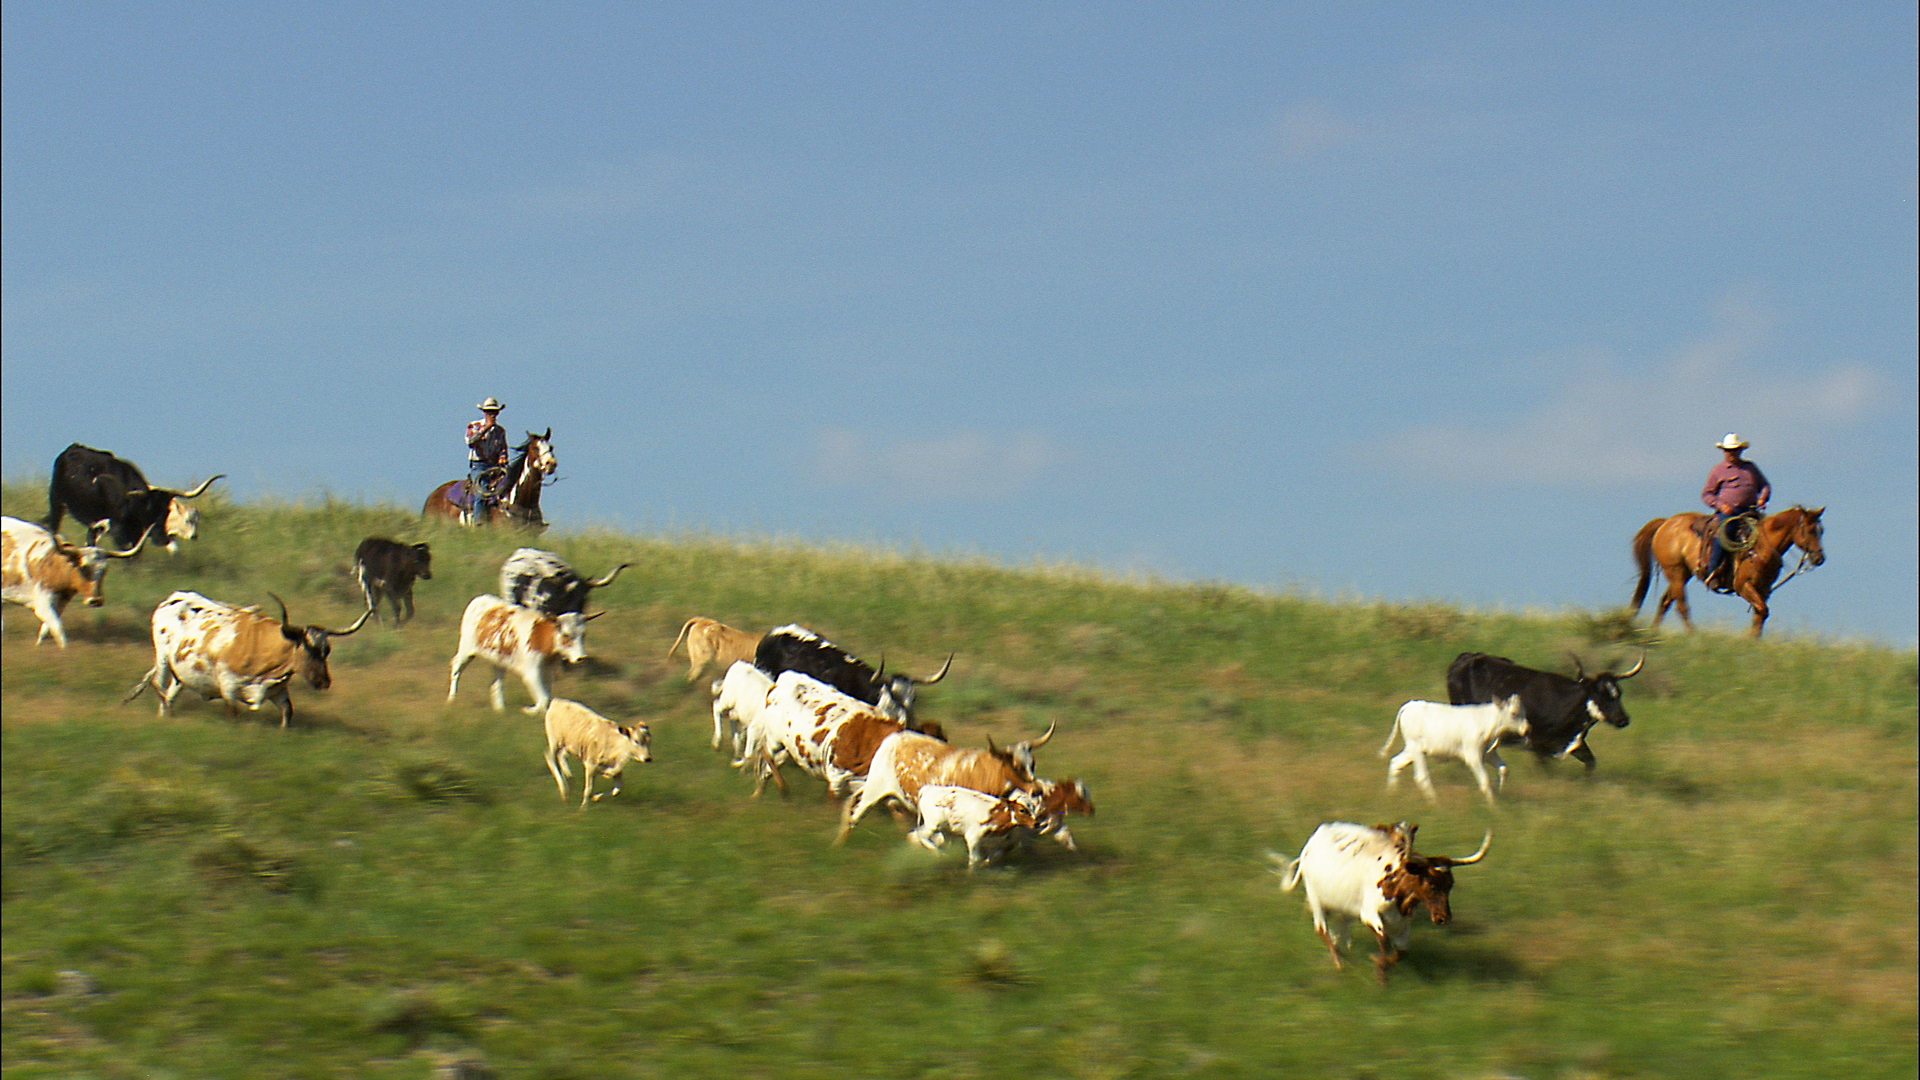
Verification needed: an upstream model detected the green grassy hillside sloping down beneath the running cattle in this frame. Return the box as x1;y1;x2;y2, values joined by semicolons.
0;484;1916;1080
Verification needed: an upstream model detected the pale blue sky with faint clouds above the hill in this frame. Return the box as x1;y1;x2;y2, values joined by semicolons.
0;0;1920;644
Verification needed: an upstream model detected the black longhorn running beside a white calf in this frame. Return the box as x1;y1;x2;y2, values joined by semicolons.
1446;653;1647;771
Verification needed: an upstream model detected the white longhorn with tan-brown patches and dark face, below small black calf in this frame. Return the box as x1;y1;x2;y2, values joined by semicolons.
127;592;372;728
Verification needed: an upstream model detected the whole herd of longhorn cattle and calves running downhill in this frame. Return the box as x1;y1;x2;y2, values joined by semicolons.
0;444;1645;980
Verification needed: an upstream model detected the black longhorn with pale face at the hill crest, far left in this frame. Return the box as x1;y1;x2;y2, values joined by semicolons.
46;442;225;552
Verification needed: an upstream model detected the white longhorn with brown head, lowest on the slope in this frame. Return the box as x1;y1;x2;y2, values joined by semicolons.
1267;821;1494;984
